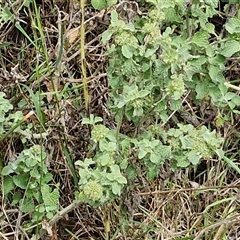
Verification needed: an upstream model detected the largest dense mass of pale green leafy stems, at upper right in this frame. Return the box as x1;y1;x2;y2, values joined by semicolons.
102;1;240;127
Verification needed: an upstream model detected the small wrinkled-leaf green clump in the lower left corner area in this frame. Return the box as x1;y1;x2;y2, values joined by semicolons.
1;145;59;223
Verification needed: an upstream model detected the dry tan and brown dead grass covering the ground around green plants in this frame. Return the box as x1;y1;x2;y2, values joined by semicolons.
0;0;240;240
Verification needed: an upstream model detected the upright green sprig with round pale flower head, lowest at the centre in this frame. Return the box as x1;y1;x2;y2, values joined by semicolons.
75;116;127;205
